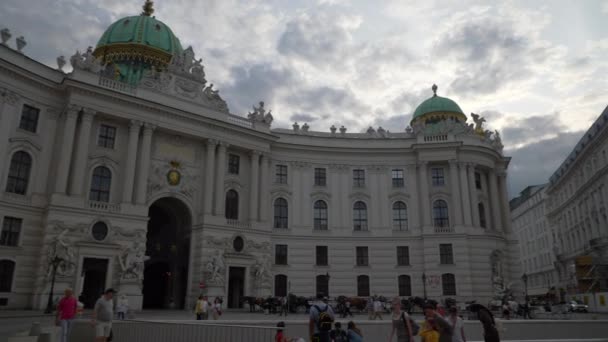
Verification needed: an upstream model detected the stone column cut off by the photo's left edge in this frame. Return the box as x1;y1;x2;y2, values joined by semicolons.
0;89;19;179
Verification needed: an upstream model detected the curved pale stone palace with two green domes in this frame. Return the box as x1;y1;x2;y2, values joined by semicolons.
0;2;520;309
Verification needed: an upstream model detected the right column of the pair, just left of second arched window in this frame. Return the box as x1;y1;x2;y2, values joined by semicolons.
70;108;95;197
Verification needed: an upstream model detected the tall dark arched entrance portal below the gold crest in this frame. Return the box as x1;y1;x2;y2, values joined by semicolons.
143;197;192;309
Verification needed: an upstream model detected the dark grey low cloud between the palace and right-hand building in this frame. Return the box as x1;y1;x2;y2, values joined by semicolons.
505;131;585;197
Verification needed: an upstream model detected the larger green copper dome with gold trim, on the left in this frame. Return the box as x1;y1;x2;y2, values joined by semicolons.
93;0;183;85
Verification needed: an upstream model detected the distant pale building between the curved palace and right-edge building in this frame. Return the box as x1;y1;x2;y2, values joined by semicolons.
509;184;558;298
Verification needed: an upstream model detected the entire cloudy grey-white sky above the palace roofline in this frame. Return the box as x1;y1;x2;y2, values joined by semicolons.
0;0;608;195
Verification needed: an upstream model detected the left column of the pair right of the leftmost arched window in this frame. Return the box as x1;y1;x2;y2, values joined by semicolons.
55;105;80;194
